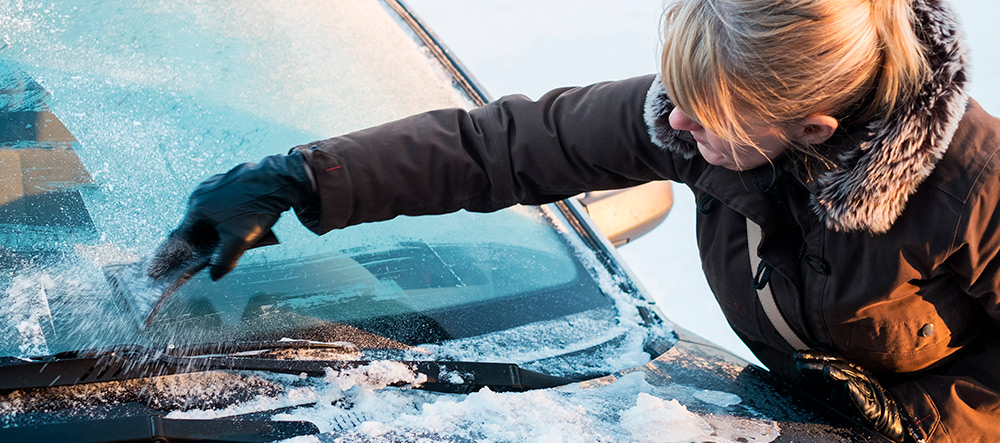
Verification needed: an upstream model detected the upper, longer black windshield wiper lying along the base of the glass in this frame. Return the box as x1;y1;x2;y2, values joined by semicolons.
0;340;578;393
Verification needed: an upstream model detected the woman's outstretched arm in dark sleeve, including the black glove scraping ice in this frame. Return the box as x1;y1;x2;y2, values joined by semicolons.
150;76;677;279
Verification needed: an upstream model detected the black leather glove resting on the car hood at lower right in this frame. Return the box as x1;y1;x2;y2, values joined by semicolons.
795;351;918;443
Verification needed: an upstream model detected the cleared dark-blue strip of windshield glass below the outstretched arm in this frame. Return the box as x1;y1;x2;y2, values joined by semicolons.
102;243;609;348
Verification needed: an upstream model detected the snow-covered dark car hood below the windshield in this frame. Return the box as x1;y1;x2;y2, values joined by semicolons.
0;331;878;441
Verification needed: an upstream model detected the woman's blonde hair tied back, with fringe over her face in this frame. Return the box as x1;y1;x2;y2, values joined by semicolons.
661;0;928;146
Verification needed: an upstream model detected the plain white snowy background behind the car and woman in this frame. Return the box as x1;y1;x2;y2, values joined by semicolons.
406;0;1000;362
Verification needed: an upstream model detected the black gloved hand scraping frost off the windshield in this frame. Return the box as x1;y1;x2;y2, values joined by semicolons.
147;151;314;280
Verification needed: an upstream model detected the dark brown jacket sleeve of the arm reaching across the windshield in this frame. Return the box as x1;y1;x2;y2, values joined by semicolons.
286;75;677;234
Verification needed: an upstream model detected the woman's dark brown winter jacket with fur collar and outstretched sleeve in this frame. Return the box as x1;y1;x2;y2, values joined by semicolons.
288;0;1000;442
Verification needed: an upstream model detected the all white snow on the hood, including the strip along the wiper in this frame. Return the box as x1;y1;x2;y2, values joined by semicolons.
162;362;780;443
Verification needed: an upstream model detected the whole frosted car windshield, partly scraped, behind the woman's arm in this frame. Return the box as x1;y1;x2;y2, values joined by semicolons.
0;0;664;378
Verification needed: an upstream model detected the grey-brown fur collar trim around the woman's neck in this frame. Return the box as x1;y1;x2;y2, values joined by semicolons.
644;0;968;234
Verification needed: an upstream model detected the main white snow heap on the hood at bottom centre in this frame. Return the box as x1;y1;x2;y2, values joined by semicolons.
316;373;778;442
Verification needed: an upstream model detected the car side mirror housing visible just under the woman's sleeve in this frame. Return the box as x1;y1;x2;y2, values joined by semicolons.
577;181;674;246
